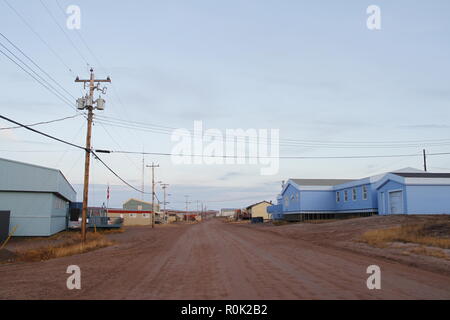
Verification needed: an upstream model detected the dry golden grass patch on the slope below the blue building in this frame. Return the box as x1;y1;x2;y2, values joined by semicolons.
361;222;450;249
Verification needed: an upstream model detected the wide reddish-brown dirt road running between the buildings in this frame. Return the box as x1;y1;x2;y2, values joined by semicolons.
0;221;450;299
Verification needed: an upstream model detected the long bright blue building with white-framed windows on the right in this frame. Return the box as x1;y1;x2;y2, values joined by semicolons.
267;168;450;221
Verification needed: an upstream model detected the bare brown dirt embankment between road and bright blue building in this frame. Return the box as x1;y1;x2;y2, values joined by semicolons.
244;215;450;275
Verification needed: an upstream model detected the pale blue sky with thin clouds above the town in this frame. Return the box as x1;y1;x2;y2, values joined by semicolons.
0;0;450;209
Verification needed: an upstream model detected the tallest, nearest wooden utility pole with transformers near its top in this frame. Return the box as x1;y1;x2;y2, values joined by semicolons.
75;68;111;242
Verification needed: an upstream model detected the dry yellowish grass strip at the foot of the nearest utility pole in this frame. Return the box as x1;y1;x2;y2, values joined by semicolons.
15;232;114;262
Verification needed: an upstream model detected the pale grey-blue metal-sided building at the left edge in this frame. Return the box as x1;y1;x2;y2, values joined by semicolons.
0;158;76;236
